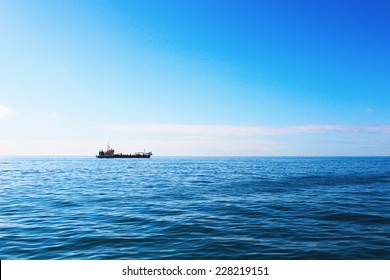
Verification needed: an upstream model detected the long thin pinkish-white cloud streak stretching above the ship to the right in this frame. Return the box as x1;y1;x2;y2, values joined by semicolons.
100;124;390;137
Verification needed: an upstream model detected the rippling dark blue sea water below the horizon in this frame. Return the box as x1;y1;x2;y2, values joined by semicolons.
0;157;390;259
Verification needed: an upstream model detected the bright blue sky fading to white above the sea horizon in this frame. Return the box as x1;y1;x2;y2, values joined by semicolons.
0;0;390;156
